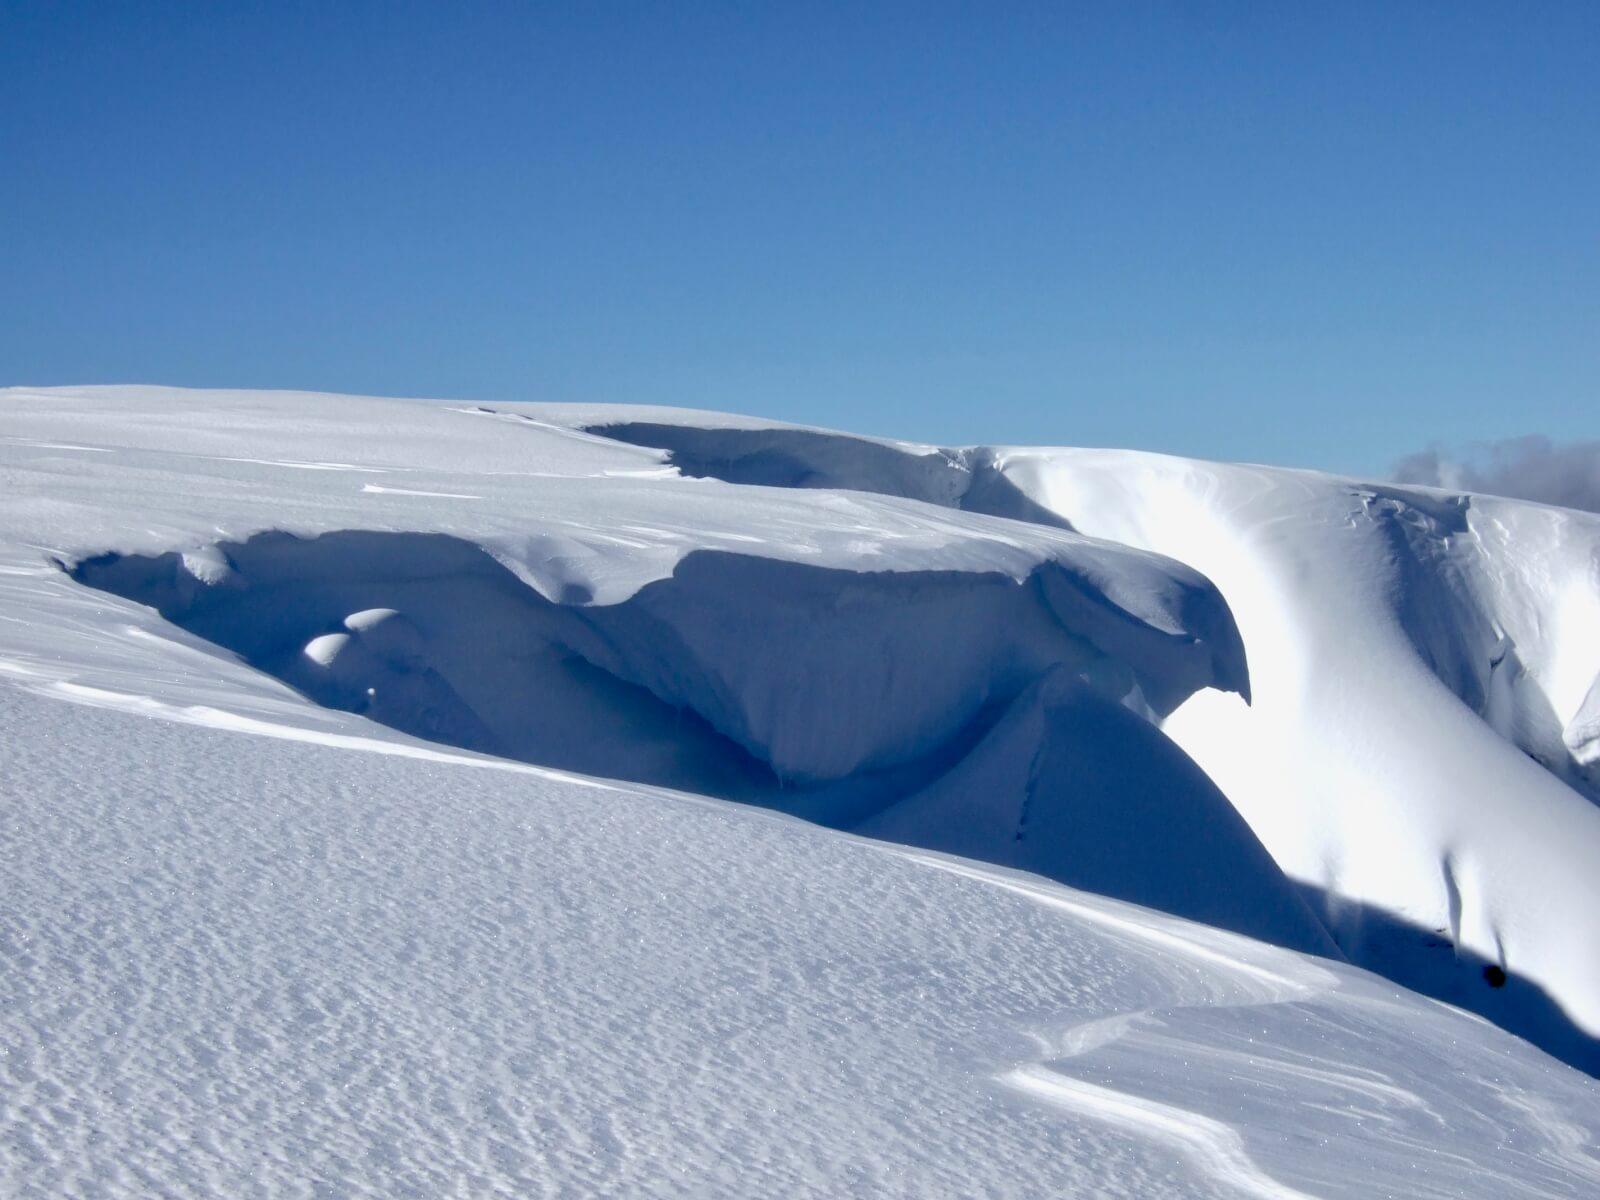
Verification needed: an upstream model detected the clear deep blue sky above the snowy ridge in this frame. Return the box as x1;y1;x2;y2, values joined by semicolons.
0;0;1600;472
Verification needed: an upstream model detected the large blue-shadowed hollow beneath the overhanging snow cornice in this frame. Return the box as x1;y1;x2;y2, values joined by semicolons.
72;531;1328;949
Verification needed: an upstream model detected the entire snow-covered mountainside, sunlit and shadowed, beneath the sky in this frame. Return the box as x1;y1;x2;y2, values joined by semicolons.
0;389;1600;1197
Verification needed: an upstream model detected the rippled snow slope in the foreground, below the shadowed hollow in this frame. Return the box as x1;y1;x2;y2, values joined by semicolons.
0;694;1600;1200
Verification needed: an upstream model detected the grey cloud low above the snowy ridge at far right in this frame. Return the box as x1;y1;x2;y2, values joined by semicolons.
1394;435;1600;512
